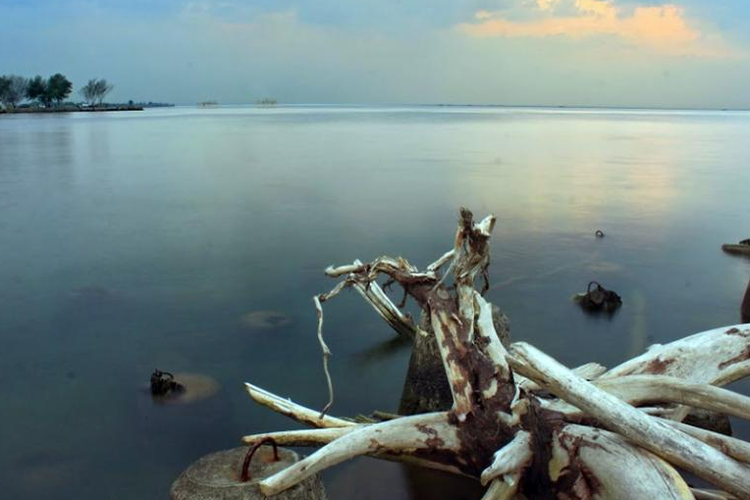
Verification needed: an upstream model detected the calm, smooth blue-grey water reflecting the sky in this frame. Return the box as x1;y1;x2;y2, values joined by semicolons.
0;107;750;500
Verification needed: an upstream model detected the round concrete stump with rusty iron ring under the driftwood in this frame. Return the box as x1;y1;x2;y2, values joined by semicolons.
169;446;326;500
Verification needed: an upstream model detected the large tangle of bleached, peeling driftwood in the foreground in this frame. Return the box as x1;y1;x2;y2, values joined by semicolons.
243;209;750;500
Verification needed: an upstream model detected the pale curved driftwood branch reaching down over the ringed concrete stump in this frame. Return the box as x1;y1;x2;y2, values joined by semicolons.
260;412;459;496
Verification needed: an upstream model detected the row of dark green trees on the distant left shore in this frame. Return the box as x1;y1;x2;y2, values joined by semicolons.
0;73;114;111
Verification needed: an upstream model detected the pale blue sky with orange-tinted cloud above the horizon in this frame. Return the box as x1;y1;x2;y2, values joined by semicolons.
0;0;750;108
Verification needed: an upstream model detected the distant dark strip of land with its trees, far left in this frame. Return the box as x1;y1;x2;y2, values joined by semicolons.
0;73;173;114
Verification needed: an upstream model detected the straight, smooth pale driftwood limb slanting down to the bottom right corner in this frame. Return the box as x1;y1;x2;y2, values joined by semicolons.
509;343;750;500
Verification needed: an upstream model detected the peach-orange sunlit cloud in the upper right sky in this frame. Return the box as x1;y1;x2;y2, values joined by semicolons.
459;0;733;57
